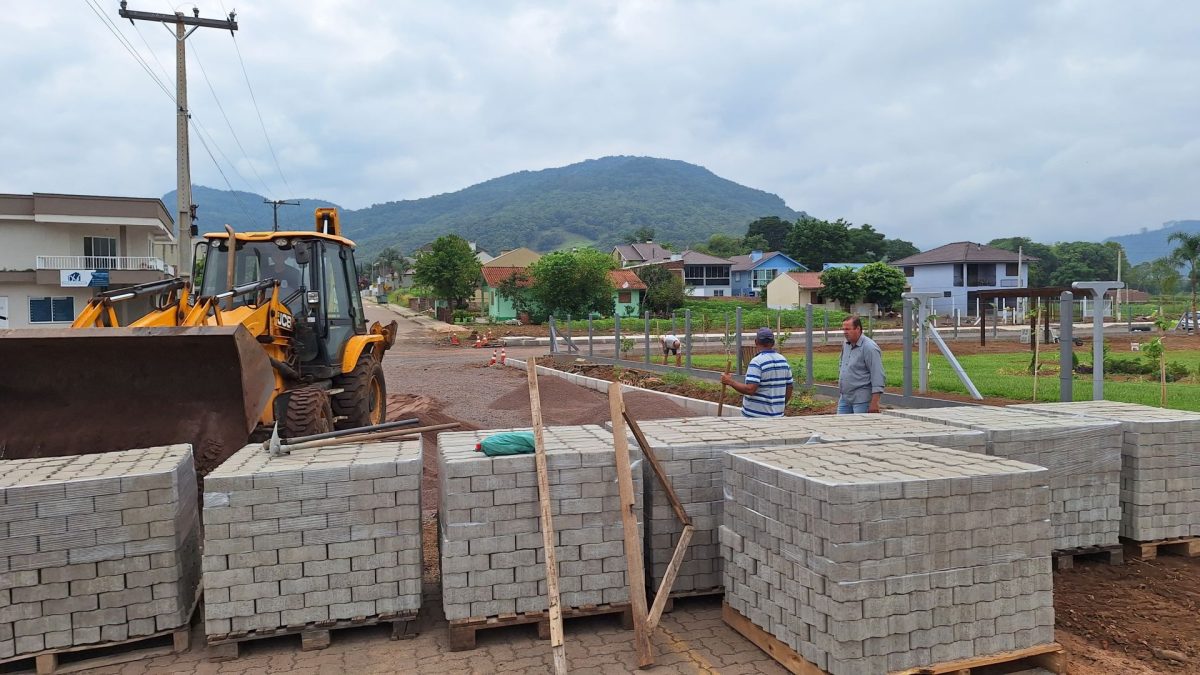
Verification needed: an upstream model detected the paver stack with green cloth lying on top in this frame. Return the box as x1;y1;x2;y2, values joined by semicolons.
438;425;642;620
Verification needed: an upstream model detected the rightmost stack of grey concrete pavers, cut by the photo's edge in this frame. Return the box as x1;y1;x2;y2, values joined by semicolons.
1013;401;1200;542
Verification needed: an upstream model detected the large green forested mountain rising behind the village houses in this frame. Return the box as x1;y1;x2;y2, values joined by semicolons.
163;156;803;258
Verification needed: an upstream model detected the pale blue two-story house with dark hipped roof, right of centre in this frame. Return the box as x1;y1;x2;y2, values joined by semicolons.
892;241;1037;316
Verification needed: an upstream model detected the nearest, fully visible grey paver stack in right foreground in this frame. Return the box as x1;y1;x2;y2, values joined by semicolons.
721;441;1054;675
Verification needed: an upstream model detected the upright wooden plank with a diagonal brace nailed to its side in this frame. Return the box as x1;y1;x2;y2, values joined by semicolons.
608;382;654;668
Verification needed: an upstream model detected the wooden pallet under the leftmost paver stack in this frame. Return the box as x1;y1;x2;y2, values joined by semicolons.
0;591;200;675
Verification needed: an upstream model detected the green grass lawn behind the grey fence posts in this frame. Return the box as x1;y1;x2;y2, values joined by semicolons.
691;346;1200;412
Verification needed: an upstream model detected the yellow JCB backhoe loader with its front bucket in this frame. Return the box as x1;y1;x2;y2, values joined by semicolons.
0;209;396;467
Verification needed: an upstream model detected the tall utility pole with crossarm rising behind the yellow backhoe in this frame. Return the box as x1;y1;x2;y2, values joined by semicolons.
119;0;238;277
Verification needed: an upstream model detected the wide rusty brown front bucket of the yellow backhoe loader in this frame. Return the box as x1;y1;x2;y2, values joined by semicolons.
0;325;274;470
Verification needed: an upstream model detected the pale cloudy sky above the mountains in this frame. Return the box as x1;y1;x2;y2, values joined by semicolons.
0;0;1200;247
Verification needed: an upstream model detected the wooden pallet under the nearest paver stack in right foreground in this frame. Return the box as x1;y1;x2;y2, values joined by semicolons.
721;603;1067;675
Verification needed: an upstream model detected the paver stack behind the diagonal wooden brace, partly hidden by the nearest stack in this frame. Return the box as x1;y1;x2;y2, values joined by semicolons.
614;414;985;593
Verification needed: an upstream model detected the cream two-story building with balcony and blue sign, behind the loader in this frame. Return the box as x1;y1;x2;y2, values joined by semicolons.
0;192;178;328
